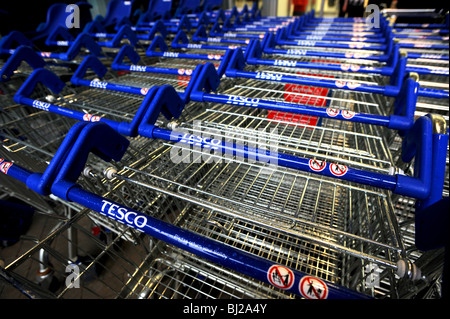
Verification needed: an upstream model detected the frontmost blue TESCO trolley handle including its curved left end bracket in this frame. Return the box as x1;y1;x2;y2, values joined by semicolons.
0;123;370;299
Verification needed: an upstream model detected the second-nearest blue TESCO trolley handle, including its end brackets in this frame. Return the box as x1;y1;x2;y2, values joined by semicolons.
14;69;446;210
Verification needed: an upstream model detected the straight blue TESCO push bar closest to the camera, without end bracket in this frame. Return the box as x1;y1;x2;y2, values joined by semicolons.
0;160;370;299
